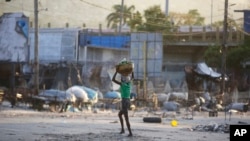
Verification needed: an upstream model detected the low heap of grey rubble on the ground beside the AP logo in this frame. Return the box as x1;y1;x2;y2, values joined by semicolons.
192;123;230;133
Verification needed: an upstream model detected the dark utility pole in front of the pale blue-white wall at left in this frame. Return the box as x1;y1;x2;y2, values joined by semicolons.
34;0;39;94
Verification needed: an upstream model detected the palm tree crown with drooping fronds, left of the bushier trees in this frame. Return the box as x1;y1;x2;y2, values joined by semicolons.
106;5;135;29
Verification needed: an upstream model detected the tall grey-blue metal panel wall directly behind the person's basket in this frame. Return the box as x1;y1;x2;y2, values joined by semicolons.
130;33;163;79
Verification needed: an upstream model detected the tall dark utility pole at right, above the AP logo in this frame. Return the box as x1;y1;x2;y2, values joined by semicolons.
221;0;228;120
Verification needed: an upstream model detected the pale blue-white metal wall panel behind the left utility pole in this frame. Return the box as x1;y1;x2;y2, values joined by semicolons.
30;28;79;62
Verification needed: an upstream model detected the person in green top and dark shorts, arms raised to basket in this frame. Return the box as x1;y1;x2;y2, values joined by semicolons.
112;71;134;137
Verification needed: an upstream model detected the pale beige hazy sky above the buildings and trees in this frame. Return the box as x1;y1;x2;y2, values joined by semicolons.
0;0;250;28
